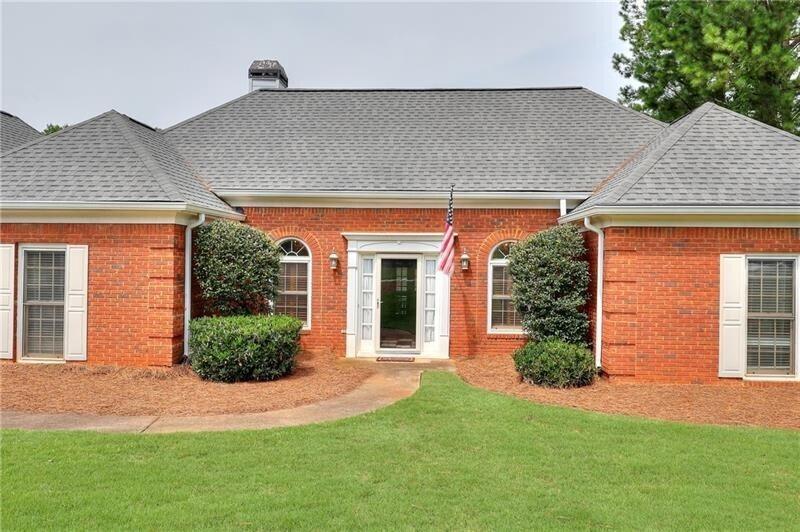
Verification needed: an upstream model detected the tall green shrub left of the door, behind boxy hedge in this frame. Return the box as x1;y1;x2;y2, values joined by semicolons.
194;221;280;316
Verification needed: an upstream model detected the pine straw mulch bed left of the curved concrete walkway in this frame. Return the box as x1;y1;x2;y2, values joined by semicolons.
0;353;373;416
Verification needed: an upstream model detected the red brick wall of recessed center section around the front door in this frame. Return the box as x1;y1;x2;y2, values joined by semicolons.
245;208;558;356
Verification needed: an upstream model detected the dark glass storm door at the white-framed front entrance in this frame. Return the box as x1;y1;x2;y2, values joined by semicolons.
378;258;418;350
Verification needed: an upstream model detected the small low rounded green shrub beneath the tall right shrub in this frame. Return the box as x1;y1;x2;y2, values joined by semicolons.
514;340;596;388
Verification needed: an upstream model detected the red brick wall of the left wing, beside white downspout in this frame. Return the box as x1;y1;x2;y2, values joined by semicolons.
0;223;184;366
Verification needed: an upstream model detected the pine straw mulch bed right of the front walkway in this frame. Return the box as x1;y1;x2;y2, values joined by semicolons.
456;357;800;429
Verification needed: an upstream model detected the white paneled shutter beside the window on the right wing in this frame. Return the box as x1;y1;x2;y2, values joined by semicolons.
719;255;747;377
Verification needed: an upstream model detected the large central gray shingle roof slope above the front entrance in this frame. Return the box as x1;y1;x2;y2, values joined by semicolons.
164;88;665;193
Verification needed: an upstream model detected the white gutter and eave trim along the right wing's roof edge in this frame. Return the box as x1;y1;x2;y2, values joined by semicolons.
558;205;800;227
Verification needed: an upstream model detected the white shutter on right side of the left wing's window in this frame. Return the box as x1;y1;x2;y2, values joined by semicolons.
64;246;89;360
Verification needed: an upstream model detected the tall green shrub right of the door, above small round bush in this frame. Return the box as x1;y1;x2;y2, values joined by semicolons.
509;225;589;345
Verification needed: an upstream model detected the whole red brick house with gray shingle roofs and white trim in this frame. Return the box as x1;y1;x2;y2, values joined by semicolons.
0;61;800;382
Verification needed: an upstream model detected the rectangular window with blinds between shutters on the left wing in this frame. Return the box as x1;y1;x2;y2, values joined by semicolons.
22;250;65;359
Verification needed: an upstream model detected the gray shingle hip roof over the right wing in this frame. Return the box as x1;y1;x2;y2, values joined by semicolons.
573;103;800;214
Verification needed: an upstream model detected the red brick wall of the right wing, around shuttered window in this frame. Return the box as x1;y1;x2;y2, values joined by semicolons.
603;227;800;382
